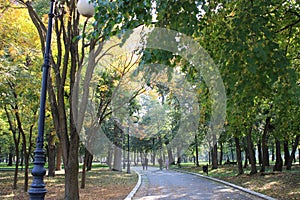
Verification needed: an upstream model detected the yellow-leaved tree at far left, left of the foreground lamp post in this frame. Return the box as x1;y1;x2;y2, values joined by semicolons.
0;1;40;191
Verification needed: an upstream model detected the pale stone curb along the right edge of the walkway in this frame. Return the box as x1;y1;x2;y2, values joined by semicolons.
172;169;275;200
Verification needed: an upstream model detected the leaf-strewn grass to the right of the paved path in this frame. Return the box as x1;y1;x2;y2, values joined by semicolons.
176;164;300;200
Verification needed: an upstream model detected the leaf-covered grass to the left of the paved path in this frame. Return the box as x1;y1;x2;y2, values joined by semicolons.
0;166;138;200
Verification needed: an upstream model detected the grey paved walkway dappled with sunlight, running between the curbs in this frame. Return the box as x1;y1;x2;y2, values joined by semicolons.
133;167;261;200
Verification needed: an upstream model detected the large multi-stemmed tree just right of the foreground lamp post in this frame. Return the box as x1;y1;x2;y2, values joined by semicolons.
18;0;152;197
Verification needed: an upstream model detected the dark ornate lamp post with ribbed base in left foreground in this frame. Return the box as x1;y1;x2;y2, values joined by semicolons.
28;0;54;200
